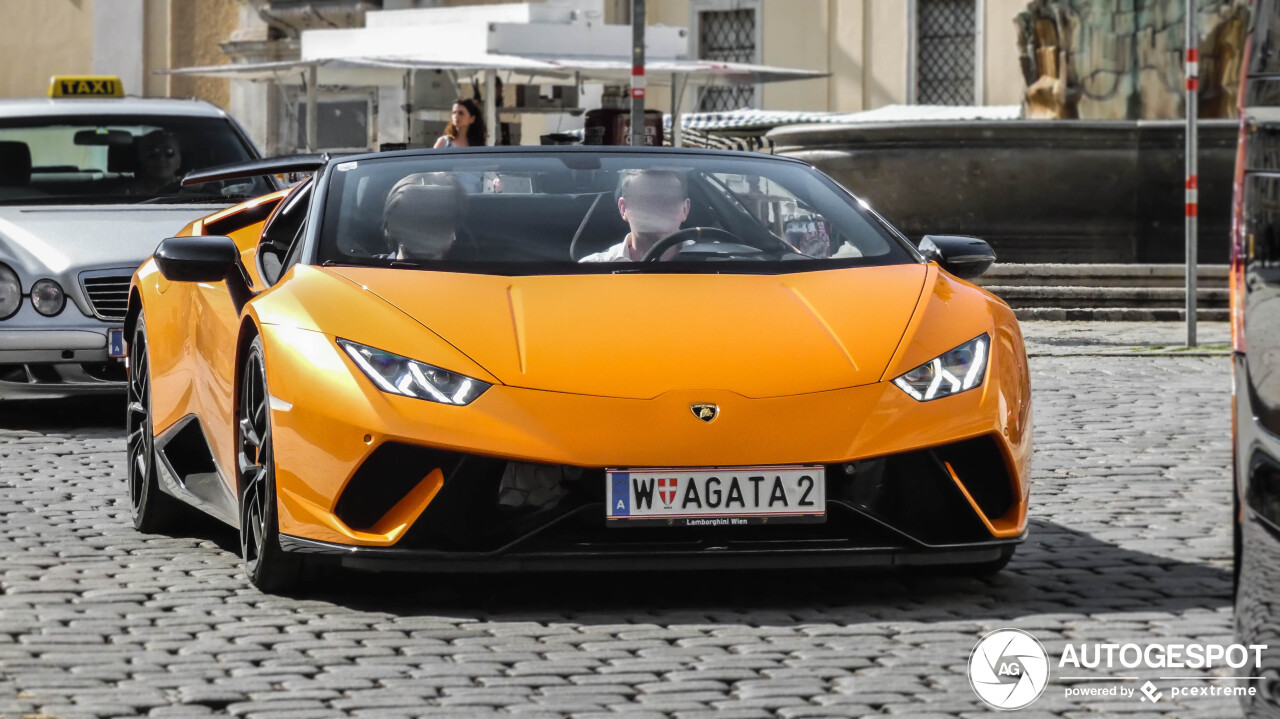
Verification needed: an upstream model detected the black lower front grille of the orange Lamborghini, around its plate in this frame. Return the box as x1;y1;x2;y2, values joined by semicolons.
335;438;998;554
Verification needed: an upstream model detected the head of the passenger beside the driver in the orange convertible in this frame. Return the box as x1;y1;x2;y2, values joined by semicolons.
379;173;466;261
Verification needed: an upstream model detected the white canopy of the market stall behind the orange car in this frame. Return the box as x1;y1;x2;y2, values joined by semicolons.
160;0;827;148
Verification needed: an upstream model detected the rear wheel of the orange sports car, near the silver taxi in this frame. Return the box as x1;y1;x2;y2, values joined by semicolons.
124;308;187;533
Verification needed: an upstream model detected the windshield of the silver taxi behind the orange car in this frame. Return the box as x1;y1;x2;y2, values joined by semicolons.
0;115;274;205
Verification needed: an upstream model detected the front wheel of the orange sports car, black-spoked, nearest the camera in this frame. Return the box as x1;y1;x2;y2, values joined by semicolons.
236;336;305;594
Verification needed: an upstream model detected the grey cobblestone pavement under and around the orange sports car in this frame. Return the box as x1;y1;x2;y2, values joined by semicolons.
0;330;1239;719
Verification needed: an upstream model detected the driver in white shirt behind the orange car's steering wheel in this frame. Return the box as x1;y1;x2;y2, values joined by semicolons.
579;169;689;262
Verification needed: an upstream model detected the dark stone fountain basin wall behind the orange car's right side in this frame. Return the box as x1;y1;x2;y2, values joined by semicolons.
768;120;1238;264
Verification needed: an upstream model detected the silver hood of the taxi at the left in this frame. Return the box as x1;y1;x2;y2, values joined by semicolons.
0;205;224;280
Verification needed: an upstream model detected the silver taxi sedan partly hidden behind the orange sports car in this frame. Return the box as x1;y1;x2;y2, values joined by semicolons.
0;89;274;399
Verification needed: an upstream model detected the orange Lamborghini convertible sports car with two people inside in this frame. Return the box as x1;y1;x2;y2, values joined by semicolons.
124;147;1030;591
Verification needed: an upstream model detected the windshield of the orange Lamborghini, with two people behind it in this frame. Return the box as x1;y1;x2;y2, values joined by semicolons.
317;151;915;275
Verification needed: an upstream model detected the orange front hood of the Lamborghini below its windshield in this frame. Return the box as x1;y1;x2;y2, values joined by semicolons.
332;265;927;398
